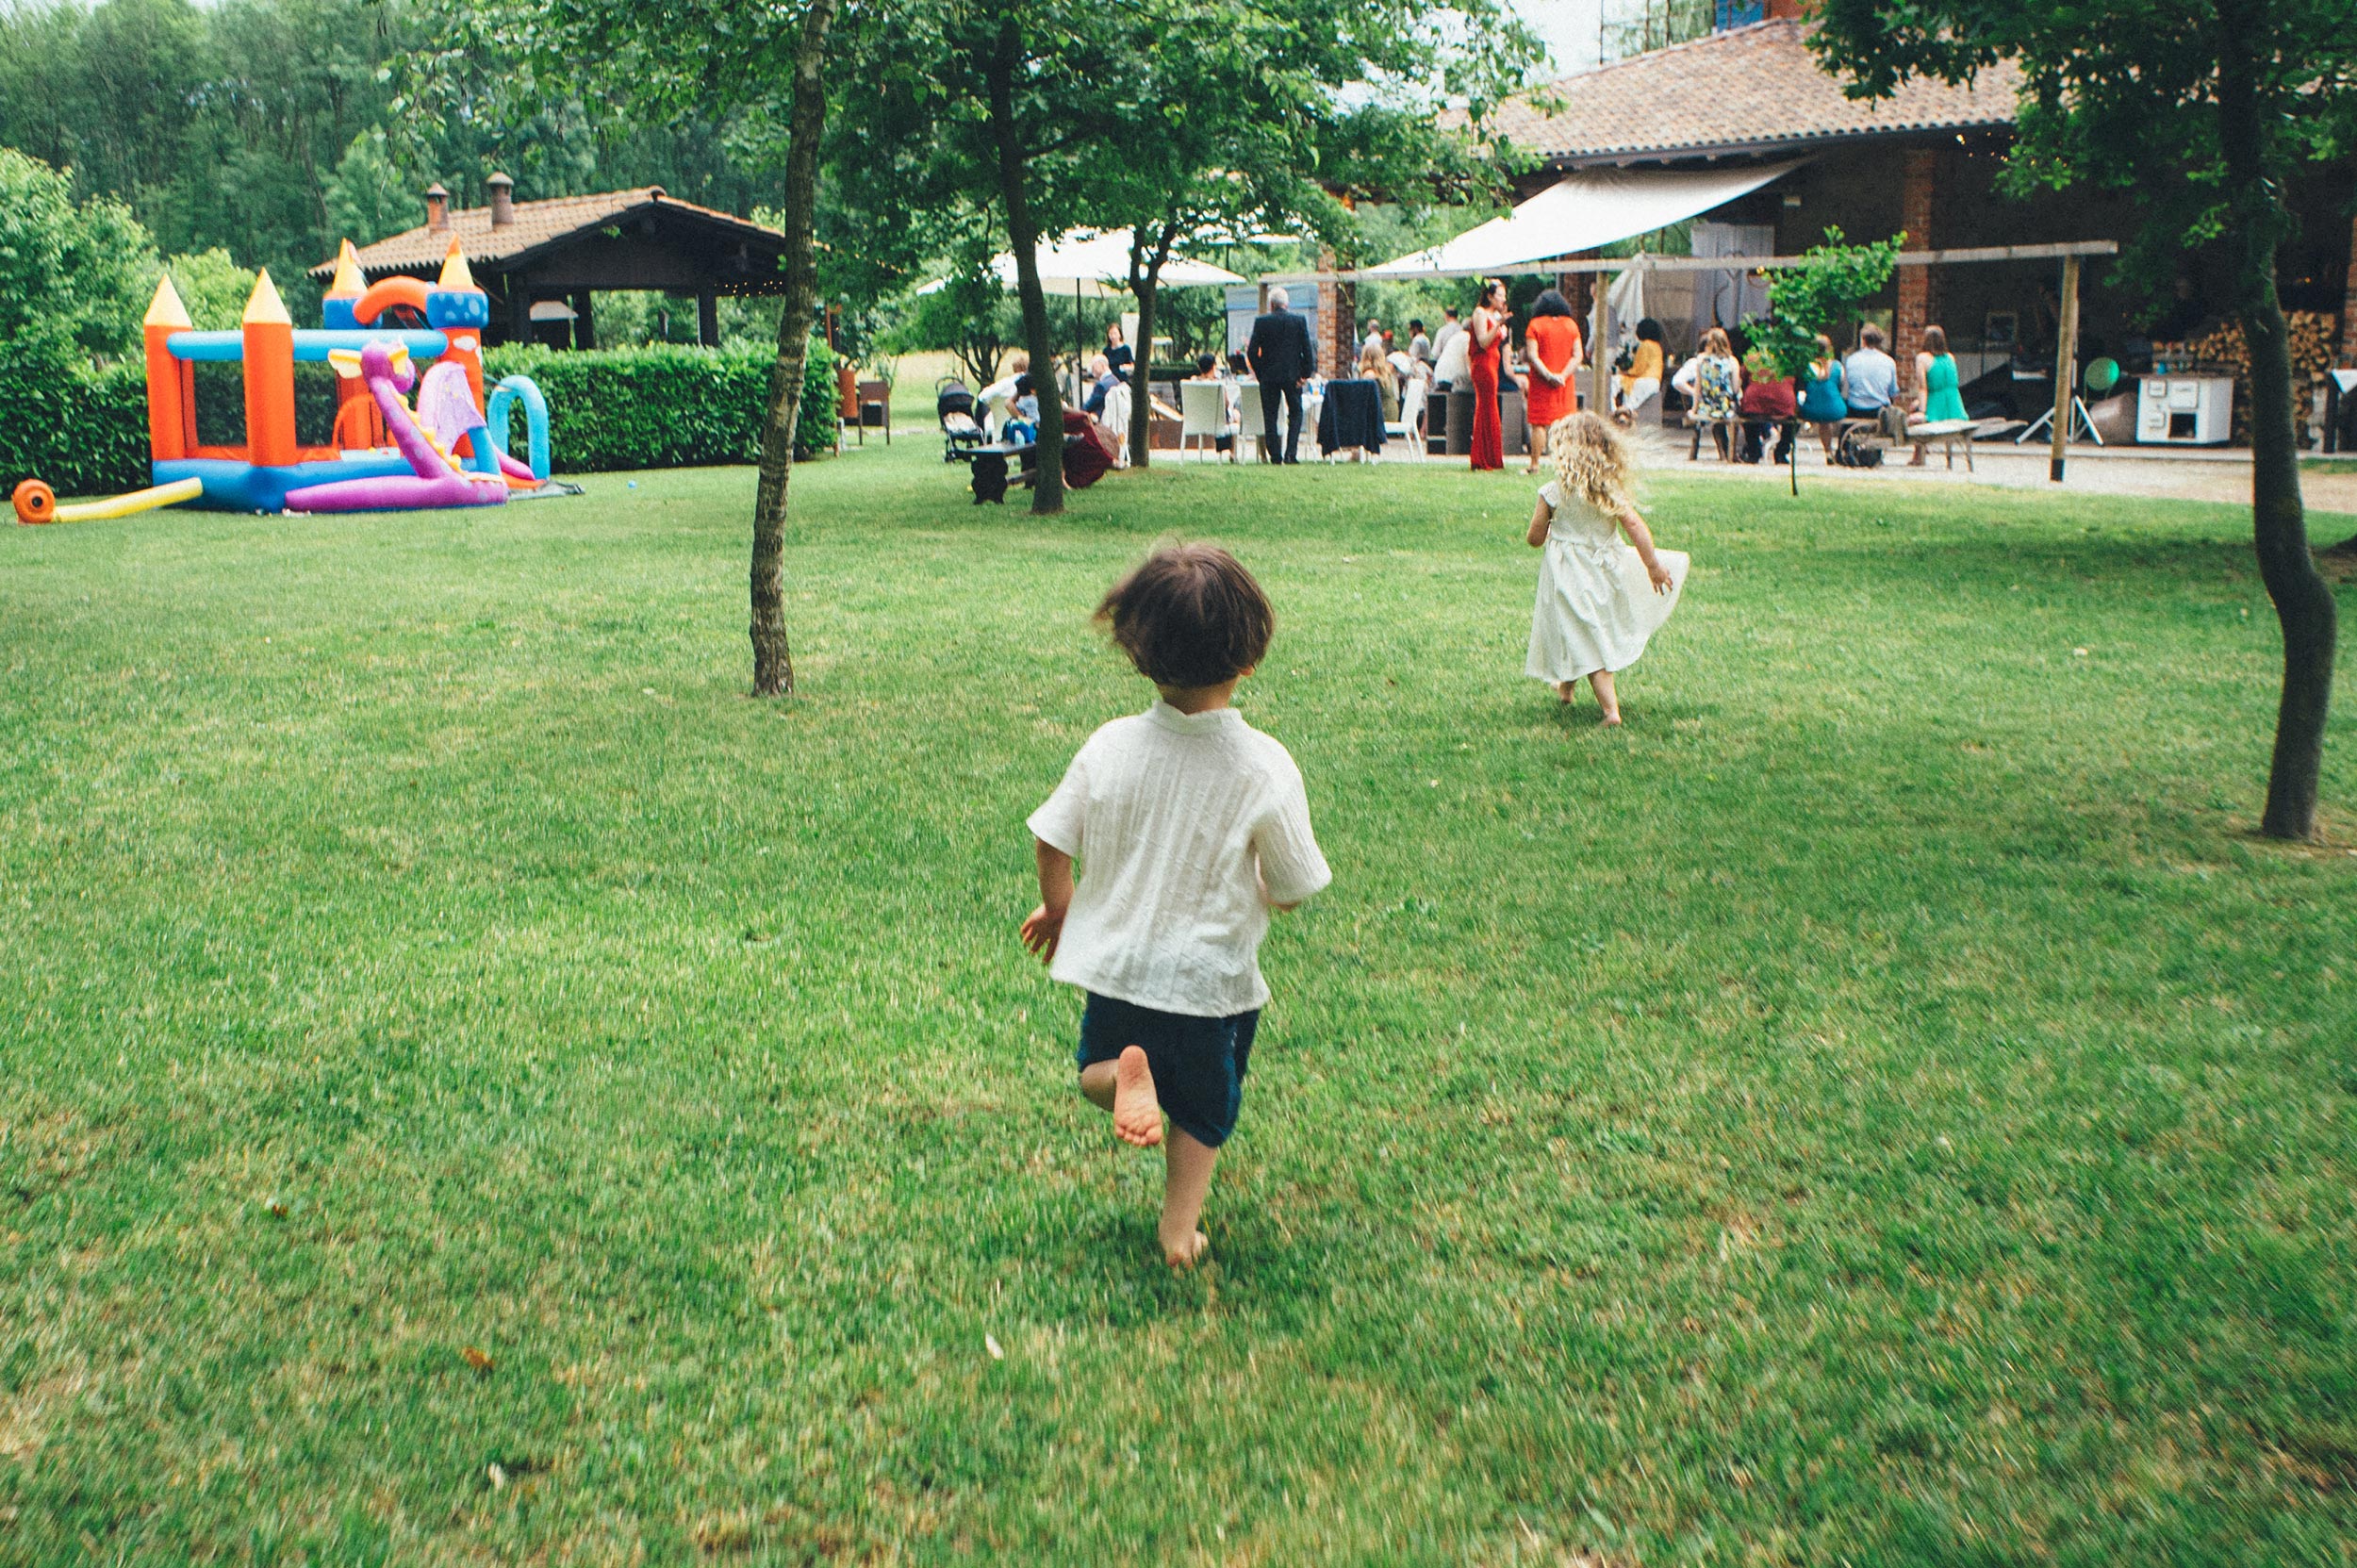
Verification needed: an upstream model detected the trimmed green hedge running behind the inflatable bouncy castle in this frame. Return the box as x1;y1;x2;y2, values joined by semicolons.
0;339;834;495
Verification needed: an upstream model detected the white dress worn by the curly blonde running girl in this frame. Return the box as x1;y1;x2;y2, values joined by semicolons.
1523;484;1686;686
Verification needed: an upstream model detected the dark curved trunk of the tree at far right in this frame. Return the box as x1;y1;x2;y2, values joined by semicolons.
2218;5;2338;839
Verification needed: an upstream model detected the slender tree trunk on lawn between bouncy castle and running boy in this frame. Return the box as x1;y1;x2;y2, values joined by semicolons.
750;0;839;698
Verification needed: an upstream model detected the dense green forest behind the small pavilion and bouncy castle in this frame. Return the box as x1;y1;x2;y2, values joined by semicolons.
0;0;776;342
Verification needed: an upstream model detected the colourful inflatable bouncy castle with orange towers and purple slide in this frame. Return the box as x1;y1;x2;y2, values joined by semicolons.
14;239;550;523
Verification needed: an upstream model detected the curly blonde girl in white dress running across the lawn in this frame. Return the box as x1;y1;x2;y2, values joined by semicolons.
1523;413;1686;726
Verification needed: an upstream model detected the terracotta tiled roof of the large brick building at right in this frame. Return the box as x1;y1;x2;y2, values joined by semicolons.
1497;22;2020;163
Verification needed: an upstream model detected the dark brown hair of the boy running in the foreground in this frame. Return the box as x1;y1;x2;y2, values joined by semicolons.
1096;545;1277;688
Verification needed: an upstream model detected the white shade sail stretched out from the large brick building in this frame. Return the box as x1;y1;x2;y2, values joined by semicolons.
1358;160;1805;278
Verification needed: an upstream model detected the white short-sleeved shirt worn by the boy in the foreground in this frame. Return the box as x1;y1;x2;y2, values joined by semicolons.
1030;701;1334;1018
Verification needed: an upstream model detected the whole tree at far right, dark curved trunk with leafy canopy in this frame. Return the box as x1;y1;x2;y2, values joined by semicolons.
1815;0;2357;839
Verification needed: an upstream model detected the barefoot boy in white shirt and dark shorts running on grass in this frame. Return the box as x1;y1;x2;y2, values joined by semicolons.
1023;545;1334;1268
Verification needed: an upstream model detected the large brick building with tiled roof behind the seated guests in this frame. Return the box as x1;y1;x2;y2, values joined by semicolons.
1327;15;2357;393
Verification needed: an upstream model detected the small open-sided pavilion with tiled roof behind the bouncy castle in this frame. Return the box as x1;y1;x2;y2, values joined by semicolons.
311;174;785;347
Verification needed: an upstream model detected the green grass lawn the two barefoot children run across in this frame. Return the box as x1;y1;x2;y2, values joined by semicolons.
0;441;2357;1565
